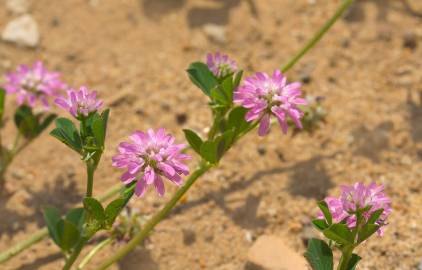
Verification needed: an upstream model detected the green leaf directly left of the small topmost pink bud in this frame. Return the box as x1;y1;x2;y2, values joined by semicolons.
187;62;217;96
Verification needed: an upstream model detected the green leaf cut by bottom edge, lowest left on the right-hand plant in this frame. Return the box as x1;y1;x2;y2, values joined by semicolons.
304;238;334;270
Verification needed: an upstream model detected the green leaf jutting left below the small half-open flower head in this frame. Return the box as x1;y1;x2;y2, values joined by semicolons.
50;118;82;153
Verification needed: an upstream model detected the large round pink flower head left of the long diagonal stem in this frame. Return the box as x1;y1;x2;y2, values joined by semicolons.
113;128;190;197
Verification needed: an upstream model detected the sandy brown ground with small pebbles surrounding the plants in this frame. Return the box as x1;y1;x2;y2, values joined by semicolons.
0;0;422;270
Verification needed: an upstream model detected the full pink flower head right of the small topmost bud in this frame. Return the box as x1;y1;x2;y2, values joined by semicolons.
234;70;307;136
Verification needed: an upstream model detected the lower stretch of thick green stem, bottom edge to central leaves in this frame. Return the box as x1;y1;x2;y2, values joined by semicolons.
98;164;212;269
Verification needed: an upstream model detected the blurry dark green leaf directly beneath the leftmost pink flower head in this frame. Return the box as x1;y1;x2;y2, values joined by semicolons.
15;105;38;138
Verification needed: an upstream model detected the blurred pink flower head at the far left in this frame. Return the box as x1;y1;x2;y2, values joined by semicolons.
4;61;66;110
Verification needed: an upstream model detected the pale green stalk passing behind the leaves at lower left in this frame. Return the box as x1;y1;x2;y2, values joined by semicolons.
0;184;122;264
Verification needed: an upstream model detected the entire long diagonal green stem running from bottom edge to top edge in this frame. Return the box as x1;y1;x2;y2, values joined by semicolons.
97;0;353;270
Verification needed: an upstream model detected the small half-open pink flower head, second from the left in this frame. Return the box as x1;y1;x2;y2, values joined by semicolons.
55;86;103;118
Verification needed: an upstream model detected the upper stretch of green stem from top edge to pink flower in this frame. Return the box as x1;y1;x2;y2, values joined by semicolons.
281;0;354;73
